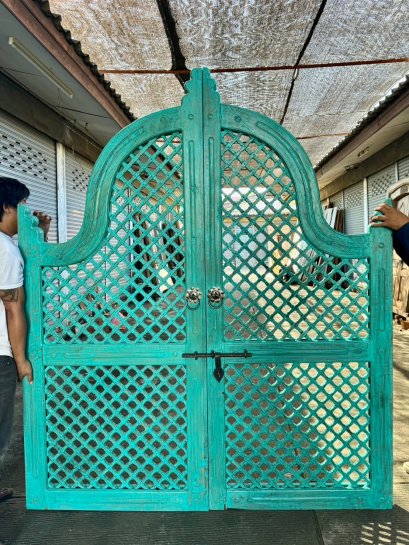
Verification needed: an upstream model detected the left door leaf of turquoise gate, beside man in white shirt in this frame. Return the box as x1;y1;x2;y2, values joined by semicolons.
20;73;208;510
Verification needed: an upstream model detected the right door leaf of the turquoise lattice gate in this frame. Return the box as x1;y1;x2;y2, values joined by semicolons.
199;70;392;509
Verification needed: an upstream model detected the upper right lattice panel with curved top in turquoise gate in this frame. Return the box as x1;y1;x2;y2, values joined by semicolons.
222;131;369;341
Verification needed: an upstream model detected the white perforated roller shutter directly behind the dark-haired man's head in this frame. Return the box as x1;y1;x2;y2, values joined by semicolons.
0;110;57;242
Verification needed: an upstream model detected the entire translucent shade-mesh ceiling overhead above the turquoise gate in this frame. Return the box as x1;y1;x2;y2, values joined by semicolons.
44;0;409;164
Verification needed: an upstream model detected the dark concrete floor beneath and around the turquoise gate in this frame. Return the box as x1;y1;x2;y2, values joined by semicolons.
0;325;409;545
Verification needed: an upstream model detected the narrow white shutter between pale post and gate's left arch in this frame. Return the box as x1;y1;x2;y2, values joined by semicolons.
65;150;94;240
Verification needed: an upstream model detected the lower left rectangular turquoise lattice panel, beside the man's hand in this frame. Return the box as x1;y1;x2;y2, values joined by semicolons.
45;365;187;490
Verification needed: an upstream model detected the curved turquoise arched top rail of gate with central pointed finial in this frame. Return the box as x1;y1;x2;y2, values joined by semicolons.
22;69;388;266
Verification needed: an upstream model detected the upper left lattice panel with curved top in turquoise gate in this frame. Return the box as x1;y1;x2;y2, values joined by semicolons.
42;133;185;343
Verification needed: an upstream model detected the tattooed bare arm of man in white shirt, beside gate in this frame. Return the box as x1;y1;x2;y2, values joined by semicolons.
0;286;33;384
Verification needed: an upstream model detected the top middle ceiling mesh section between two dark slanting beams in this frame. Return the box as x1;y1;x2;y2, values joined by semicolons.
170;0;321;68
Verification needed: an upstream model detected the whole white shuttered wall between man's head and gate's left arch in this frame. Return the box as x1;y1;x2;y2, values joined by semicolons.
0;110;93;242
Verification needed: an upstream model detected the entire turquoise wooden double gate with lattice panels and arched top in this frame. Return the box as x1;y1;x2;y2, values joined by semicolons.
20;70;391;510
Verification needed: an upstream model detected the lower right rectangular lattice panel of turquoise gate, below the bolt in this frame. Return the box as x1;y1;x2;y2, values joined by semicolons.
225;362;370;489
